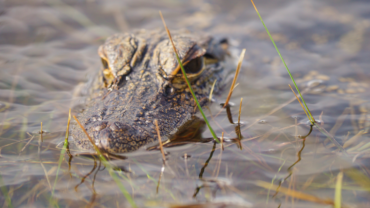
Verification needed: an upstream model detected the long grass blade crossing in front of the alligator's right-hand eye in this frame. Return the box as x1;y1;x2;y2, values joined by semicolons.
159;12;220;143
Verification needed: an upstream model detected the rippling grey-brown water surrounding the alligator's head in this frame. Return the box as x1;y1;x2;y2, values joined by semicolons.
0;0;370;207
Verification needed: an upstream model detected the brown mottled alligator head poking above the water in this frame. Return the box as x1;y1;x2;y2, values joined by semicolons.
72;30;228;153
